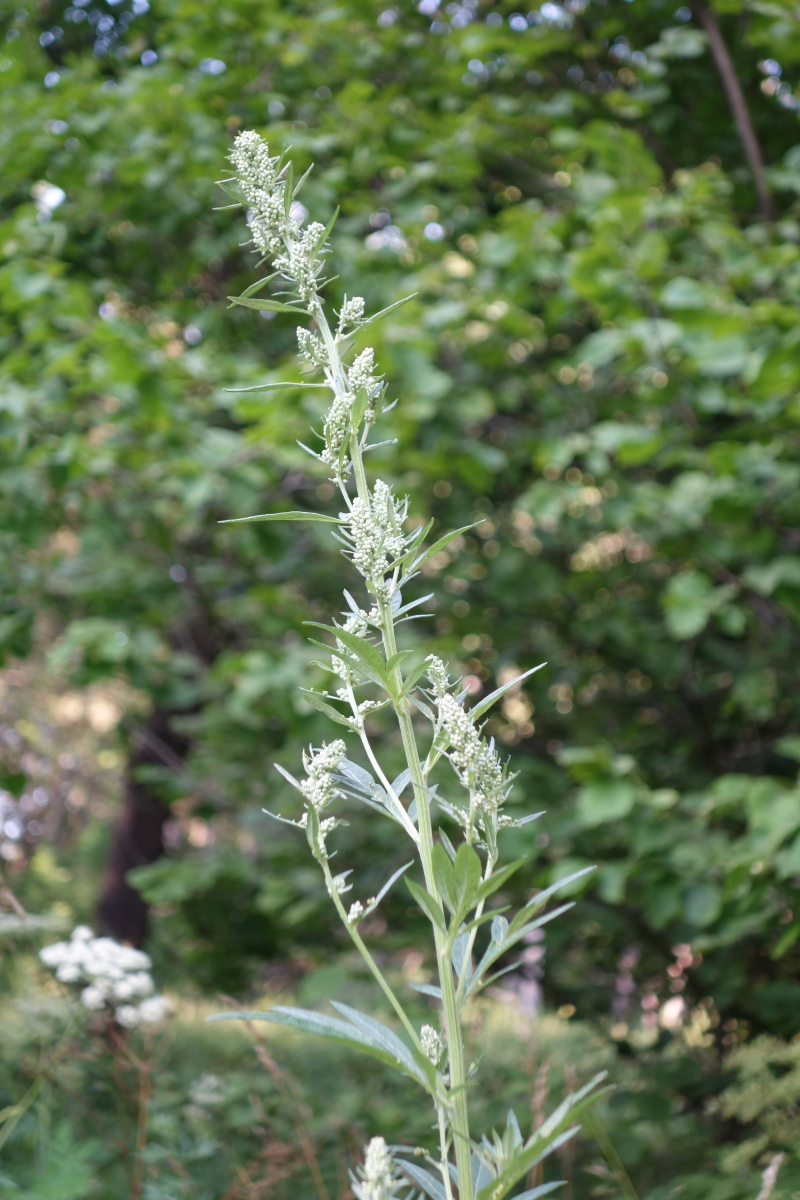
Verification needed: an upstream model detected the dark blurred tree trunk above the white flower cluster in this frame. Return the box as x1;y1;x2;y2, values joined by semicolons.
97;708;188;946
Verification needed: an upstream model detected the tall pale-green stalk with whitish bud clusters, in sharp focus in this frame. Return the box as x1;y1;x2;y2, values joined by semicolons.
209;132;600;1200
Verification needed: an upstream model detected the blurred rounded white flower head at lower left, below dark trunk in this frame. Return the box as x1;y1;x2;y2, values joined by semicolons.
40;925;172;1028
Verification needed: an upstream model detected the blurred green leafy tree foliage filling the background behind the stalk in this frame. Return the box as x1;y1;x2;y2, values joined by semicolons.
0;0;800;1196
